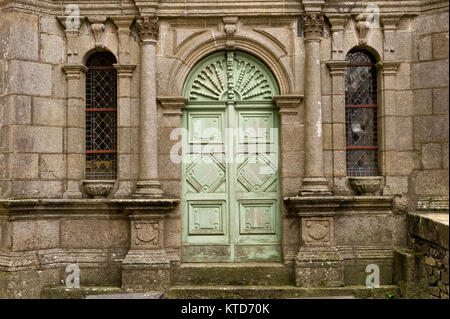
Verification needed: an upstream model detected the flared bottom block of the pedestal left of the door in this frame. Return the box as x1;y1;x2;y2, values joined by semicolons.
122;249;170;291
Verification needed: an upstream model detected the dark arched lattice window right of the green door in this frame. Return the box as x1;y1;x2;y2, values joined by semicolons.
345;50;378;176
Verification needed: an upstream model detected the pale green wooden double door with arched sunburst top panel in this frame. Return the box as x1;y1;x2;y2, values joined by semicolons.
182;52;281;262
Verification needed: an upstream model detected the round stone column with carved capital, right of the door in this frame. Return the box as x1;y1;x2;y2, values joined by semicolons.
300;13;331;196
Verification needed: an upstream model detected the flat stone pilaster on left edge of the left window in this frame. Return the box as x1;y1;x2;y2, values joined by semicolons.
63;64;87;198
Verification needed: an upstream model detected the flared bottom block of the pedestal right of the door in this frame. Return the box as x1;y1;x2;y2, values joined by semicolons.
295;246;344;287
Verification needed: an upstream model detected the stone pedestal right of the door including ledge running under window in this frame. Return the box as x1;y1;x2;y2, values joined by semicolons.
284;196;392;287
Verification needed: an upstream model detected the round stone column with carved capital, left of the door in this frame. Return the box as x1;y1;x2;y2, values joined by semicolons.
134;16;163;198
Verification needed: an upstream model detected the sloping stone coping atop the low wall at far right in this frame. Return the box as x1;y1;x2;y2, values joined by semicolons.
408;212;449;250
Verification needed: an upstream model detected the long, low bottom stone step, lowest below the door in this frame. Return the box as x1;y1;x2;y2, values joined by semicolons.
165;285;400;299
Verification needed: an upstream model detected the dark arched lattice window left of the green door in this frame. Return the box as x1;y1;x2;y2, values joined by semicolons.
86;52;117;180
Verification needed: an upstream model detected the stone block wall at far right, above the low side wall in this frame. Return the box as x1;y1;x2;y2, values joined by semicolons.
411;8;449;199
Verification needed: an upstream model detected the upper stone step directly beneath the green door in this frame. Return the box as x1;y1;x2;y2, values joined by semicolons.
171;263;294;286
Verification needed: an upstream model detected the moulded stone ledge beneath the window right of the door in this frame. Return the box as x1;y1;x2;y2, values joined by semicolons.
283;196;394;216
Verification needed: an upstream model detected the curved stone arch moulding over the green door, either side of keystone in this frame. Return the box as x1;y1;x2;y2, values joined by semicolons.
168;33;292;96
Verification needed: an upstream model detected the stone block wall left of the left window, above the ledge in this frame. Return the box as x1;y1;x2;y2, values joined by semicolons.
0;12;66;198
